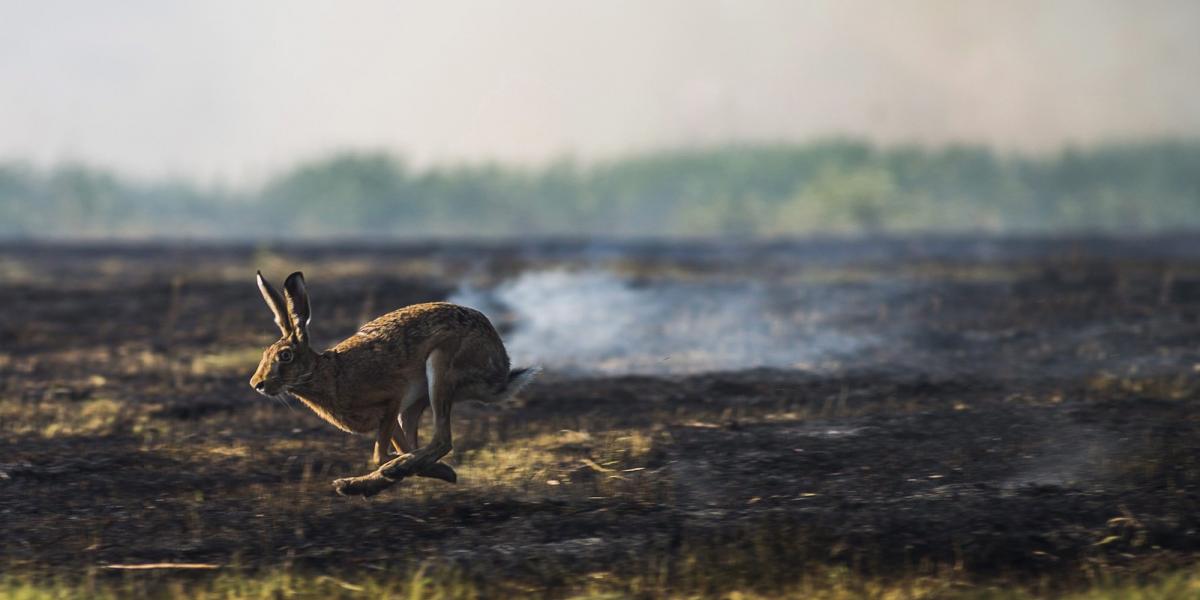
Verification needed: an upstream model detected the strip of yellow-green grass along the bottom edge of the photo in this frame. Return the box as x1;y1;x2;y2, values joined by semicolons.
0;566;1200;600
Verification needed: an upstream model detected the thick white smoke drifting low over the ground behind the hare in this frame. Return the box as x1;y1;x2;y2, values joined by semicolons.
451;270;869;373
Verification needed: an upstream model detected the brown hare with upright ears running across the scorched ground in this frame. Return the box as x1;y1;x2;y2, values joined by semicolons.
250;271;539;496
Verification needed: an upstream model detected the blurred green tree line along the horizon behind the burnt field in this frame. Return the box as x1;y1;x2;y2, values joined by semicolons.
0;140;1200;239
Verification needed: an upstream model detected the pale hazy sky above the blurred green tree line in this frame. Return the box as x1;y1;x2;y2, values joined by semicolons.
0;0;1200;181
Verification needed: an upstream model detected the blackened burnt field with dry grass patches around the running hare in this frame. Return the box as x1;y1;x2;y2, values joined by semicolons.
0;238;1200;596
